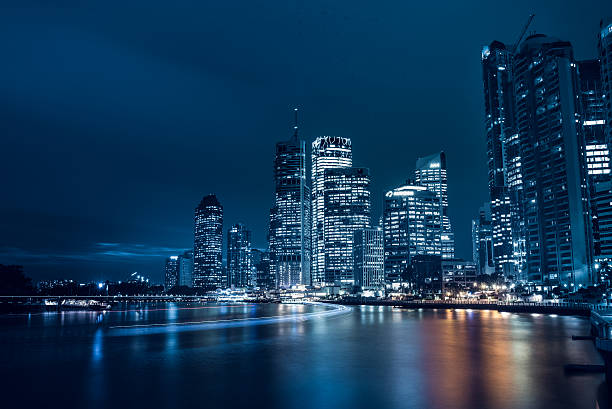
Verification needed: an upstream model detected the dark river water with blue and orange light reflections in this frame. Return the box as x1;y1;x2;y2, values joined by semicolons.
0;304;604;409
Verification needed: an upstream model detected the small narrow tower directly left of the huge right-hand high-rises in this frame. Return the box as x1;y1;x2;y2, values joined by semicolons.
472;202;495;274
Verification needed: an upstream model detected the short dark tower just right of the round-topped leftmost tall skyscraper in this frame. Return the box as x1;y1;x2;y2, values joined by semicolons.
227;223;254;287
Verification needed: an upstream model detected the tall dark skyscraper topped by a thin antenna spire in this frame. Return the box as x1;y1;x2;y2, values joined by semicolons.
269;108;311;287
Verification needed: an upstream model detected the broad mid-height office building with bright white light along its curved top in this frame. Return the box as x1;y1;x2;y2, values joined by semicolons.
383;182;443;282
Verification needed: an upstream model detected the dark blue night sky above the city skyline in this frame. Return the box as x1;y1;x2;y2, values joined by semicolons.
0;0;612;282
